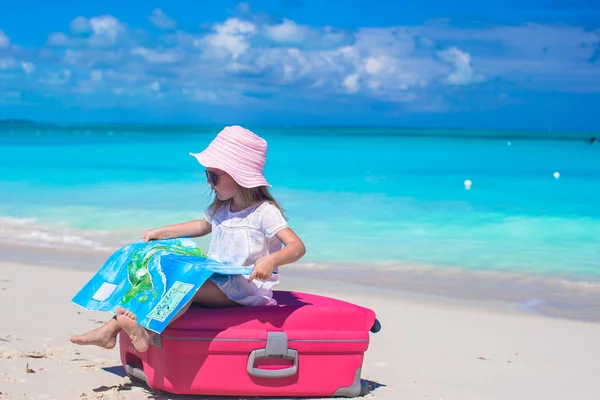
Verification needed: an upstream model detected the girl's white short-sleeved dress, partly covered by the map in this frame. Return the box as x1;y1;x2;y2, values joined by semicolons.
205;201;288;306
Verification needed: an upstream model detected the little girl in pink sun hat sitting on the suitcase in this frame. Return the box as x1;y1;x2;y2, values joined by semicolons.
71;126;306;351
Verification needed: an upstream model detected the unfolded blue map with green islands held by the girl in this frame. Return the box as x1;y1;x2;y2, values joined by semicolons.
72;239;252;333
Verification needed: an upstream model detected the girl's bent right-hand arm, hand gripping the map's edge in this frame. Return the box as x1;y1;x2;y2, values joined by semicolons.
248;228;306;282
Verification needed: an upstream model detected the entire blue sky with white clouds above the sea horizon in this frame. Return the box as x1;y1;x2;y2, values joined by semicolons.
0;0;600;130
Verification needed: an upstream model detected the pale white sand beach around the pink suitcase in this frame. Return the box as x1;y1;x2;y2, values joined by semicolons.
0;247;600;400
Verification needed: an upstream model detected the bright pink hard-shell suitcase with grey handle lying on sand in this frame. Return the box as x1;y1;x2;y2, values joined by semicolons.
120;291;380;397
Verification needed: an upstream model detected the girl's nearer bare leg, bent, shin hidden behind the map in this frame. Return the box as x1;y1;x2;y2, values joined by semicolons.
117;280;239;352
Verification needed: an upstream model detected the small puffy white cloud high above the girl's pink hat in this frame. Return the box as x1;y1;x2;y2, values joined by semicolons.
204;18;256;60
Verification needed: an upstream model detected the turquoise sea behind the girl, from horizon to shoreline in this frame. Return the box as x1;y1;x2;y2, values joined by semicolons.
0;124;600;316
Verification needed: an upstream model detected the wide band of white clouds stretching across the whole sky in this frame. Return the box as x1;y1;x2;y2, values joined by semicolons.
9;9;600;109
